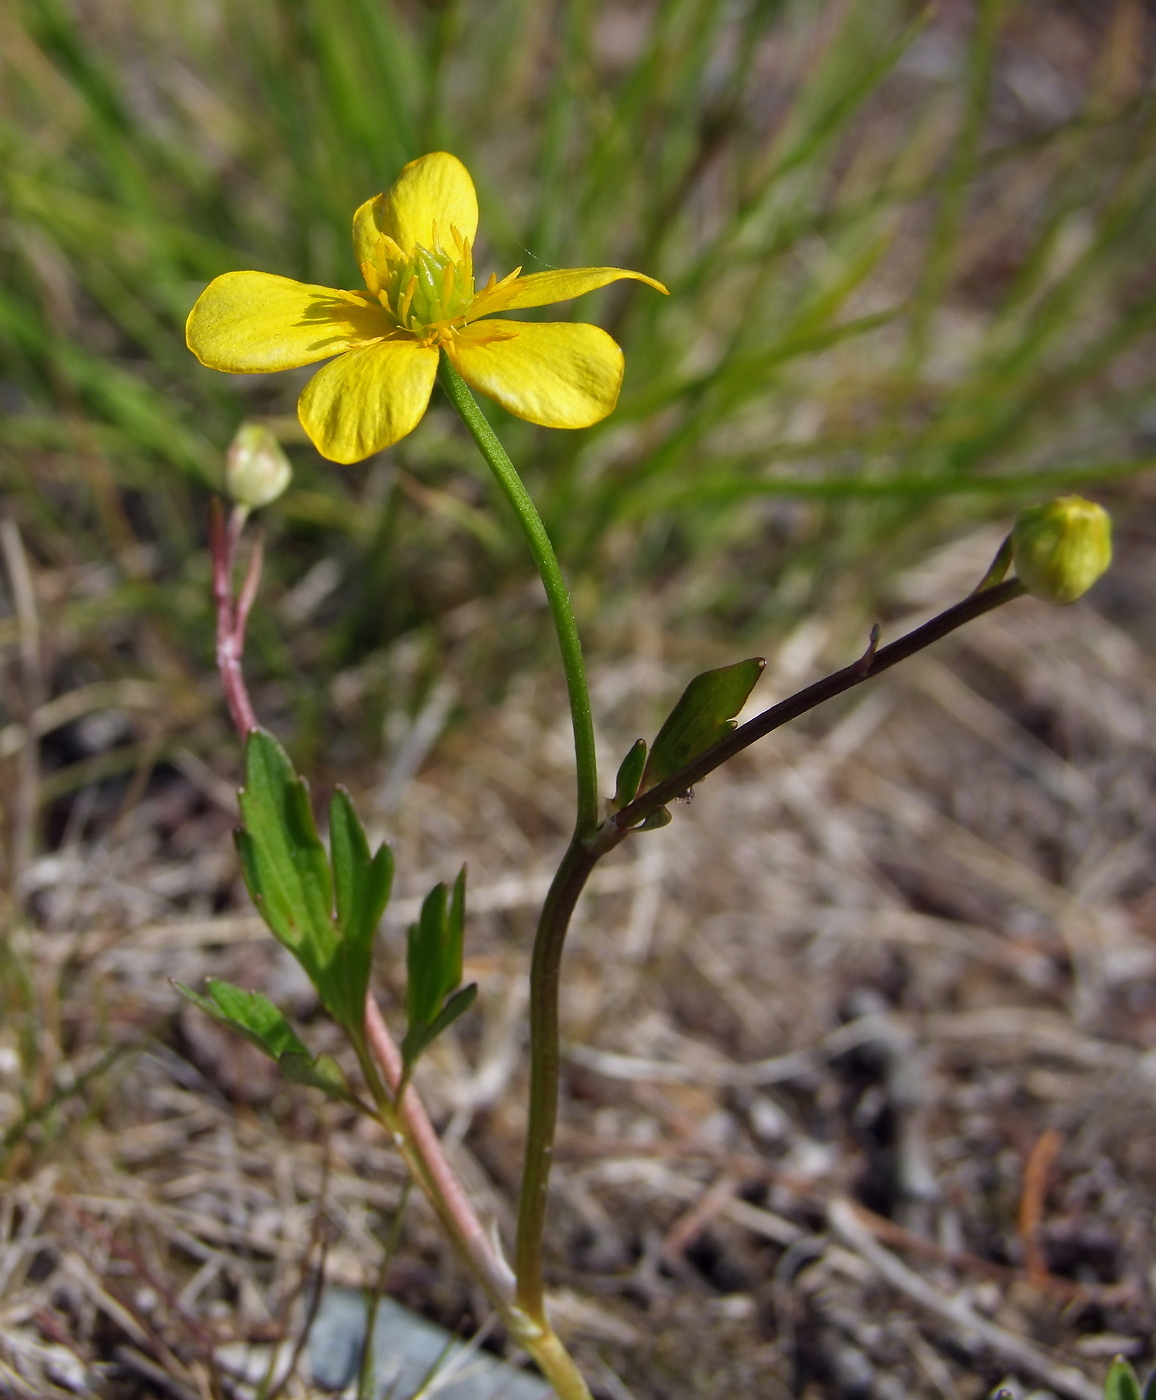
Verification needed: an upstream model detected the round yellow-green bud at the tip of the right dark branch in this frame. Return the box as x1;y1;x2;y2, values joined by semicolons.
1012;496;1111;603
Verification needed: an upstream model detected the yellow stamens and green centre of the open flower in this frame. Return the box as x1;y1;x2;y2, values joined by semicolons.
361;223;522;346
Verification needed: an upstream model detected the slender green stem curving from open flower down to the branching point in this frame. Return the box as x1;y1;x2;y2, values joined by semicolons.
439;356;599;839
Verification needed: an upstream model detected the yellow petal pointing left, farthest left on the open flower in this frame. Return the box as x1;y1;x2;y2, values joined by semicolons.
185;272;393;374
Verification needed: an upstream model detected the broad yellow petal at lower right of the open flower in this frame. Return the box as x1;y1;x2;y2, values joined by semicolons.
448;321;623;428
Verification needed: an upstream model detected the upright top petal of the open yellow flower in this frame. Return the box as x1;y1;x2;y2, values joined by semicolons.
372;151;477;266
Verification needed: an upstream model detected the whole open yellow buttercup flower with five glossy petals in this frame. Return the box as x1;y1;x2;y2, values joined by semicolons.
185;151;666;462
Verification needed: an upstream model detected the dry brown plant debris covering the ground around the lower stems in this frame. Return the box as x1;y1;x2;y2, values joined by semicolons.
0;501;1156;1400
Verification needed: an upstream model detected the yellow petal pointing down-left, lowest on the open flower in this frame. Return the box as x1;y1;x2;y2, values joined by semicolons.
297;337;438;462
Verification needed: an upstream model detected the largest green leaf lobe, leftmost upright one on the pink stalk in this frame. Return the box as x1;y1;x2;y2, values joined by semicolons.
237;729;337;991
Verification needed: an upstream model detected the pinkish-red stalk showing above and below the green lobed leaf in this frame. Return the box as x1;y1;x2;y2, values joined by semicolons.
209;500;515;1315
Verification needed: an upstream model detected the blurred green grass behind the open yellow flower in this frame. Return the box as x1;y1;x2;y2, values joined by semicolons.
0;0;1156;767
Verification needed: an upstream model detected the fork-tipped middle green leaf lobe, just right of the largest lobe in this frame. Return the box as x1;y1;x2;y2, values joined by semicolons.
326;788;393;1032
